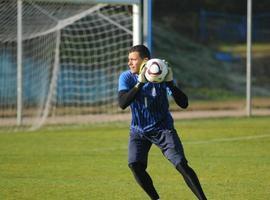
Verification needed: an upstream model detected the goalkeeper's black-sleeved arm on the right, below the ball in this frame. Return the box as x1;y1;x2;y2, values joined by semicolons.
166;81;188;108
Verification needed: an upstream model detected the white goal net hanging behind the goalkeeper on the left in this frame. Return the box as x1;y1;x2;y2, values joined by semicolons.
0;0;133;128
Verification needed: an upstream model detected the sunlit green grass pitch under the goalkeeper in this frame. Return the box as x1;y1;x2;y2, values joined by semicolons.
0;117;270;200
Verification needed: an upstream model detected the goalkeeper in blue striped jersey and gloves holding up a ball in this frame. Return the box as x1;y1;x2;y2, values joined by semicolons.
118;45;206;200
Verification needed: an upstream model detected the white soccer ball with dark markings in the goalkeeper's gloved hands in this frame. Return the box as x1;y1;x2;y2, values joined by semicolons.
145;58;168;83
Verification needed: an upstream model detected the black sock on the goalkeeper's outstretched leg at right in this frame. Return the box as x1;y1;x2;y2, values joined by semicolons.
176;161;207;200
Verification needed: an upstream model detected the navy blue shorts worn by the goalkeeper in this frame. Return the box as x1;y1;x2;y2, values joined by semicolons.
128;129;186;166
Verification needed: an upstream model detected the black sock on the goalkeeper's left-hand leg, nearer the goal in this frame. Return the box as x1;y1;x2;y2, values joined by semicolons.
128;162;159;200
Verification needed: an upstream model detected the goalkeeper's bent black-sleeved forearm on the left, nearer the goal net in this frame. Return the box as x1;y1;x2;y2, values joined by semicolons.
118;82;144;110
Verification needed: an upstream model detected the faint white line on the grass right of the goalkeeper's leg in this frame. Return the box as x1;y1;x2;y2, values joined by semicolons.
183;134;270;144
